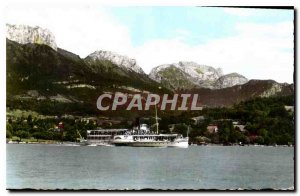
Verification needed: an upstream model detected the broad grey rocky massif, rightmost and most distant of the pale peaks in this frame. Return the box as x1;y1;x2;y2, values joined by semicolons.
149;61;248;89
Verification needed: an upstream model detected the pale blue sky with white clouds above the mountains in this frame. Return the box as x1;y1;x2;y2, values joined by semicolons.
5;3;294;83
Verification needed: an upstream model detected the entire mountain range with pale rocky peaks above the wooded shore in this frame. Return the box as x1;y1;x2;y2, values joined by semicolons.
6;24;294;115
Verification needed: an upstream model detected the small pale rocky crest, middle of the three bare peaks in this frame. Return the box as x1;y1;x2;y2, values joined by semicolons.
85;50;145;74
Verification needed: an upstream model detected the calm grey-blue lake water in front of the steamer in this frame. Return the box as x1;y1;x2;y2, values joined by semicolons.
6;144;294;190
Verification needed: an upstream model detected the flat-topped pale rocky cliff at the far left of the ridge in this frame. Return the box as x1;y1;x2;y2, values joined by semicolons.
6;24;57;51
